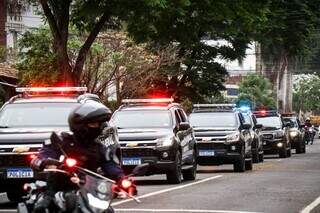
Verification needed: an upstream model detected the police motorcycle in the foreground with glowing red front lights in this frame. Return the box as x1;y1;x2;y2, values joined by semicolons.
18;128;149;213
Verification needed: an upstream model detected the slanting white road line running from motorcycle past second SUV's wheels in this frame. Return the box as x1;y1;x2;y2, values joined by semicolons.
112;175;222;206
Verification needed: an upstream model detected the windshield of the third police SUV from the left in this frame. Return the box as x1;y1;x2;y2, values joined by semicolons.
190;112;238;127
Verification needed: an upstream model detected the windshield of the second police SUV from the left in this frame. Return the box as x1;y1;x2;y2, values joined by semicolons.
112;110;172;128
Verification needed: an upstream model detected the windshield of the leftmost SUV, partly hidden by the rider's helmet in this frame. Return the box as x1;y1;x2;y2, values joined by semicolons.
0;103;78;128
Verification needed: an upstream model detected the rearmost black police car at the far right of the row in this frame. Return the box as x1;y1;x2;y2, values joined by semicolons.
282;114;306;154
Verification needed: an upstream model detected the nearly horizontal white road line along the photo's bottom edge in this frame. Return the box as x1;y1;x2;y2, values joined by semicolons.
115;209;259;213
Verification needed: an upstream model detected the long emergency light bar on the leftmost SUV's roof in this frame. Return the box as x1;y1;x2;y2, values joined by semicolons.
16;87;88;93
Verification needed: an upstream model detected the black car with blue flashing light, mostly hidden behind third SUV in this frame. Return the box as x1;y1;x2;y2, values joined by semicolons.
242;110;264;163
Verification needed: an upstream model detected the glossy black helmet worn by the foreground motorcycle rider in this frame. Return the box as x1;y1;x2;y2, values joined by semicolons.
68;100;112;144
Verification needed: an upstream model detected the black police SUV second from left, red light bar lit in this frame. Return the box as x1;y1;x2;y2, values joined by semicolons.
112;99;197;183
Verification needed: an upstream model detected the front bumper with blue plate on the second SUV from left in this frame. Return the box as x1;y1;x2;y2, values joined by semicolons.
121;147;176;175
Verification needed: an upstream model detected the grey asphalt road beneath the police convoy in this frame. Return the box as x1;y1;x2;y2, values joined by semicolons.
0;140;320;213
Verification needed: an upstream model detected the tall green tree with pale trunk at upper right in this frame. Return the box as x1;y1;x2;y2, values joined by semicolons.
256;0;320;111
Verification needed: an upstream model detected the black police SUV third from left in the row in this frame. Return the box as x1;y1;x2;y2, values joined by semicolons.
189;104;252;172
